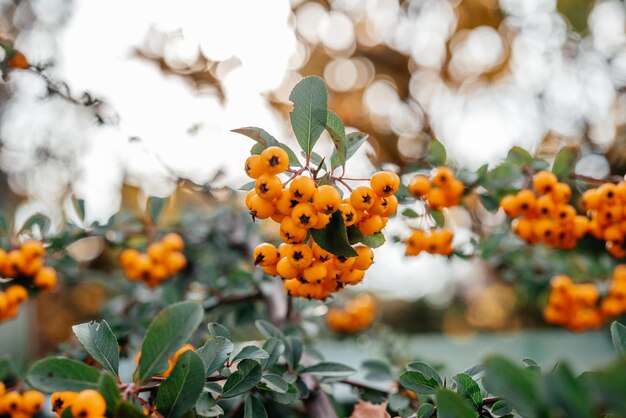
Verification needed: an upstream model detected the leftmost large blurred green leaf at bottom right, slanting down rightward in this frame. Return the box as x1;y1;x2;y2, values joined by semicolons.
482;357;541;417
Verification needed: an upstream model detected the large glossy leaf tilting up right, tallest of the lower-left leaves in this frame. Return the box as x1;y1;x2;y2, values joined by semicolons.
135;302;203;384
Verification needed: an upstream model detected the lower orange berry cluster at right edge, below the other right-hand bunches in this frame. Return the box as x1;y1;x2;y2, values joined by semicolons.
543;264;626;331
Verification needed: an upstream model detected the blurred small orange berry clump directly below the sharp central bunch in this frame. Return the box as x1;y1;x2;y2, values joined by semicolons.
326;294;376;334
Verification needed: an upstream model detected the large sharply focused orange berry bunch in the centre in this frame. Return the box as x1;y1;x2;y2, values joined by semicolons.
245;147;400;299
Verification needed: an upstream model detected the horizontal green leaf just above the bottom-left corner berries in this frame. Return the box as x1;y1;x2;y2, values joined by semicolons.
26;357;100;393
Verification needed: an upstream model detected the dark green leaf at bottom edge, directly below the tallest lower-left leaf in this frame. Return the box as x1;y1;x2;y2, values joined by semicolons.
156;351;206;418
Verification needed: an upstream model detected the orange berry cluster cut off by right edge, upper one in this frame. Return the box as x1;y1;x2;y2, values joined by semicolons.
582;181;626;258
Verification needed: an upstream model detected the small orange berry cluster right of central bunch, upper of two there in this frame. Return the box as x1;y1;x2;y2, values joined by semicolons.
408;166;465;210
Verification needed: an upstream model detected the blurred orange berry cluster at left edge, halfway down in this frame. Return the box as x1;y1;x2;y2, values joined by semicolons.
0;241;58;321
